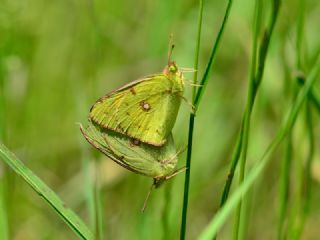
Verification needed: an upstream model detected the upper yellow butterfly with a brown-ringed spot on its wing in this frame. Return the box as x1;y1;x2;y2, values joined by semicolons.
89;48;184;146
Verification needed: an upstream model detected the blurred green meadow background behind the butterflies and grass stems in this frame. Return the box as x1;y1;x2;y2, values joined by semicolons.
0;0;320;240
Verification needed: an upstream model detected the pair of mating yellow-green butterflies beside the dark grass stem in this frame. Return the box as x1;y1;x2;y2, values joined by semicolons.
81;58;184;187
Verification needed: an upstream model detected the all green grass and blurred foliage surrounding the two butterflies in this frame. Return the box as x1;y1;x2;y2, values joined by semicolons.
0;0;320;240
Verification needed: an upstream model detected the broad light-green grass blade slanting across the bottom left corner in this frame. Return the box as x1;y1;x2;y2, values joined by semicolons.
0;143;93;240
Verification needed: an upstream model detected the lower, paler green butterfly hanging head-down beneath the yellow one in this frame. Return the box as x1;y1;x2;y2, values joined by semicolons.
80;121;180;187
